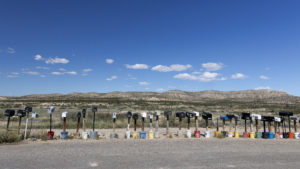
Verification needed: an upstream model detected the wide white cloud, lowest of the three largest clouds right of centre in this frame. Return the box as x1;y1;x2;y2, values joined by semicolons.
174;72;226;82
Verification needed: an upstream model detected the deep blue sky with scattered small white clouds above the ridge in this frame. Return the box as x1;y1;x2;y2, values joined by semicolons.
0;0;300;96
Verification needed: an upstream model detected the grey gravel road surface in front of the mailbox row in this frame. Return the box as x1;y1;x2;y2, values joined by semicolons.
0;138;300;169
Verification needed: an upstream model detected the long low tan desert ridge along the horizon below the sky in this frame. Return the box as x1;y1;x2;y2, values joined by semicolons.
0;90;300;103
